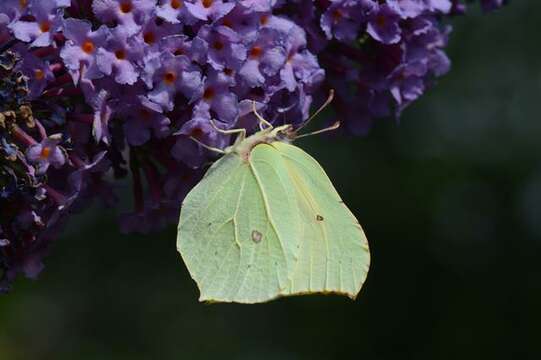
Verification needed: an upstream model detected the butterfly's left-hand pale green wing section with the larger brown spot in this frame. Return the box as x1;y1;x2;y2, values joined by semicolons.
177;145;300;303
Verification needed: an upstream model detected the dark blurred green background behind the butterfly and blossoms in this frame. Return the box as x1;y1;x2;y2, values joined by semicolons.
0;0;541;360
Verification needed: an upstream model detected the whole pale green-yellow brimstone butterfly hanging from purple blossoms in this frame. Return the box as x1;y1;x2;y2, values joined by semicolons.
177;91;370;303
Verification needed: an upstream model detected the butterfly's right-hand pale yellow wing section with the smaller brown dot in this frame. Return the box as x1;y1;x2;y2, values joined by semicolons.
272;142;370;298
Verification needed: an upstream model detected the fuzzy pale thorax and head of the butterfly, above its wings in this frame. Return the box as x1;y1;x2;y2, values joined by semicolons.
225;124;294;161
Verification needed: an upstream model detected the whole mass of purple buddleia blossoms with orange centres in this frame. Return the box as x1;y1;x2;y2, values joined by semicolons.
0;0;504;289
